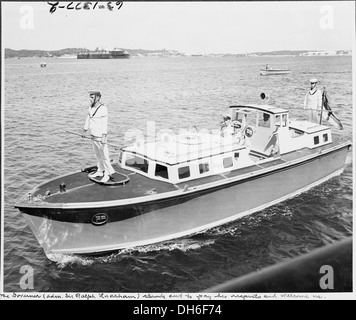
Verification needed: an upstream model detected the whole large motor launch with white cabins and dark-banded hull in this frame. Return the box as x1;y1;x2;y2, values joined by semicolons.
15;105;351;260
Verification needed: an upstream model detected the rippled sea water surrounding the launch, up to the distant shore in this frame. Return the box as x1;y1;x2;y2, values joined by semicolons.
3;57;353;292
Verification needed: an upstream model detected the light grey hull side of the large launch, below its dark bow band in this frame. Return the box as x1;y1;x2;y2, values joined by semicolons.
23;144;349;260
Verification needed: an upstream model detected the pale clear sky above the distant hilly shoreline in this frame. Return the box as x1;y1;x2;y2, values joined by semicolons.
1;1;355;54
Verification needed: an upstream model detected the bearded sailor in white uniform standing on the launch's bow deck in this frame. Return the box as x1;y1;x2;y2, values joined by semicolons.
82;90;115;182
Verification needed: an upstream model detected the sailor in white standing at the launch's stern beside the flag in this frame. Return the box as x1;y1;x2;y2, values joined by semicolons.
303;78;323;123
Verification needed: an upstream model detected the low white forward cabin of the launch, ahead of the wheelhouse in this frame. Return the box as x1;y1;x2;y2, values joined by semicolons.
119;130;254;184
